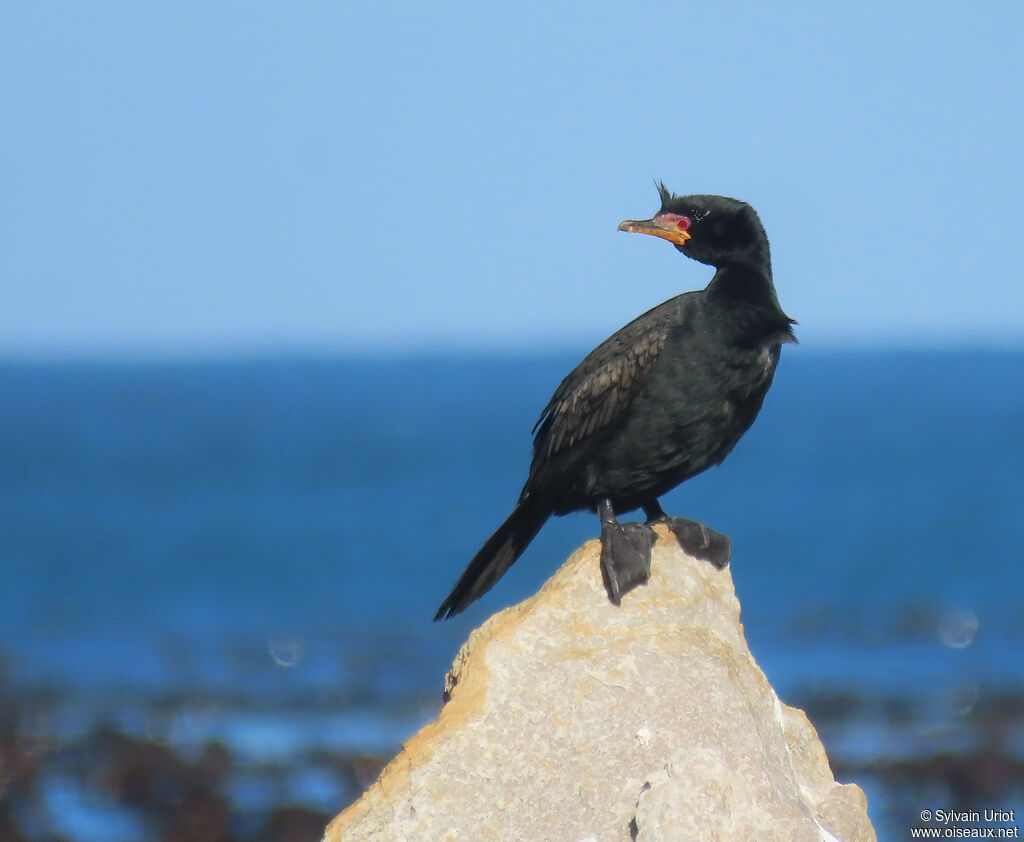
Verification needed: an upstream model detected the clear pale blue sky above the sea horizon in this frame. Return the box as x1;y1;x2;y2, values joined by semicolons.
0;0;1024;355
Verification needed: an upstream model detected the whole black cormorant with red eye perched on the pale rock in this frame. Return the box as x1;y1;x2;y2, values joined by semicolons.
434;184;796;620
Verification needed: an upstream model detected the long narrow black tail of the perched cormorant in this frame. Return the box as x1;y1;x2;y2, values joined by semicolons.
434;501;551;620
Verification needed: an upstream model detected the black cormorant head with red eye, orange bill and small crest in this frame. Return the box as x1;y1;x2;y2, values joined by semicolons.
618;182;771;272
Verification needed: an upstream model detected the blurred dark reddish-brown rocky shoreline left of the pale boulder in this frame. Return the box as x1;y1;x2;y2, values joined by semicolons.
0;700;385;842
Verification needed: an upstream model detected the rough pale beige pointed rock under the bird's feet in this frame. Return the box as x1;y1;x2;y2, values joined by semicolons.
325;528;874;842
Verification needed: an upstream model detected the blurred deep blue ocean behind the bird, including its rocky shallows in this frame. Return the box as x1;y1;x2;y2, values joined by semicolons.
0;346;1024;842
